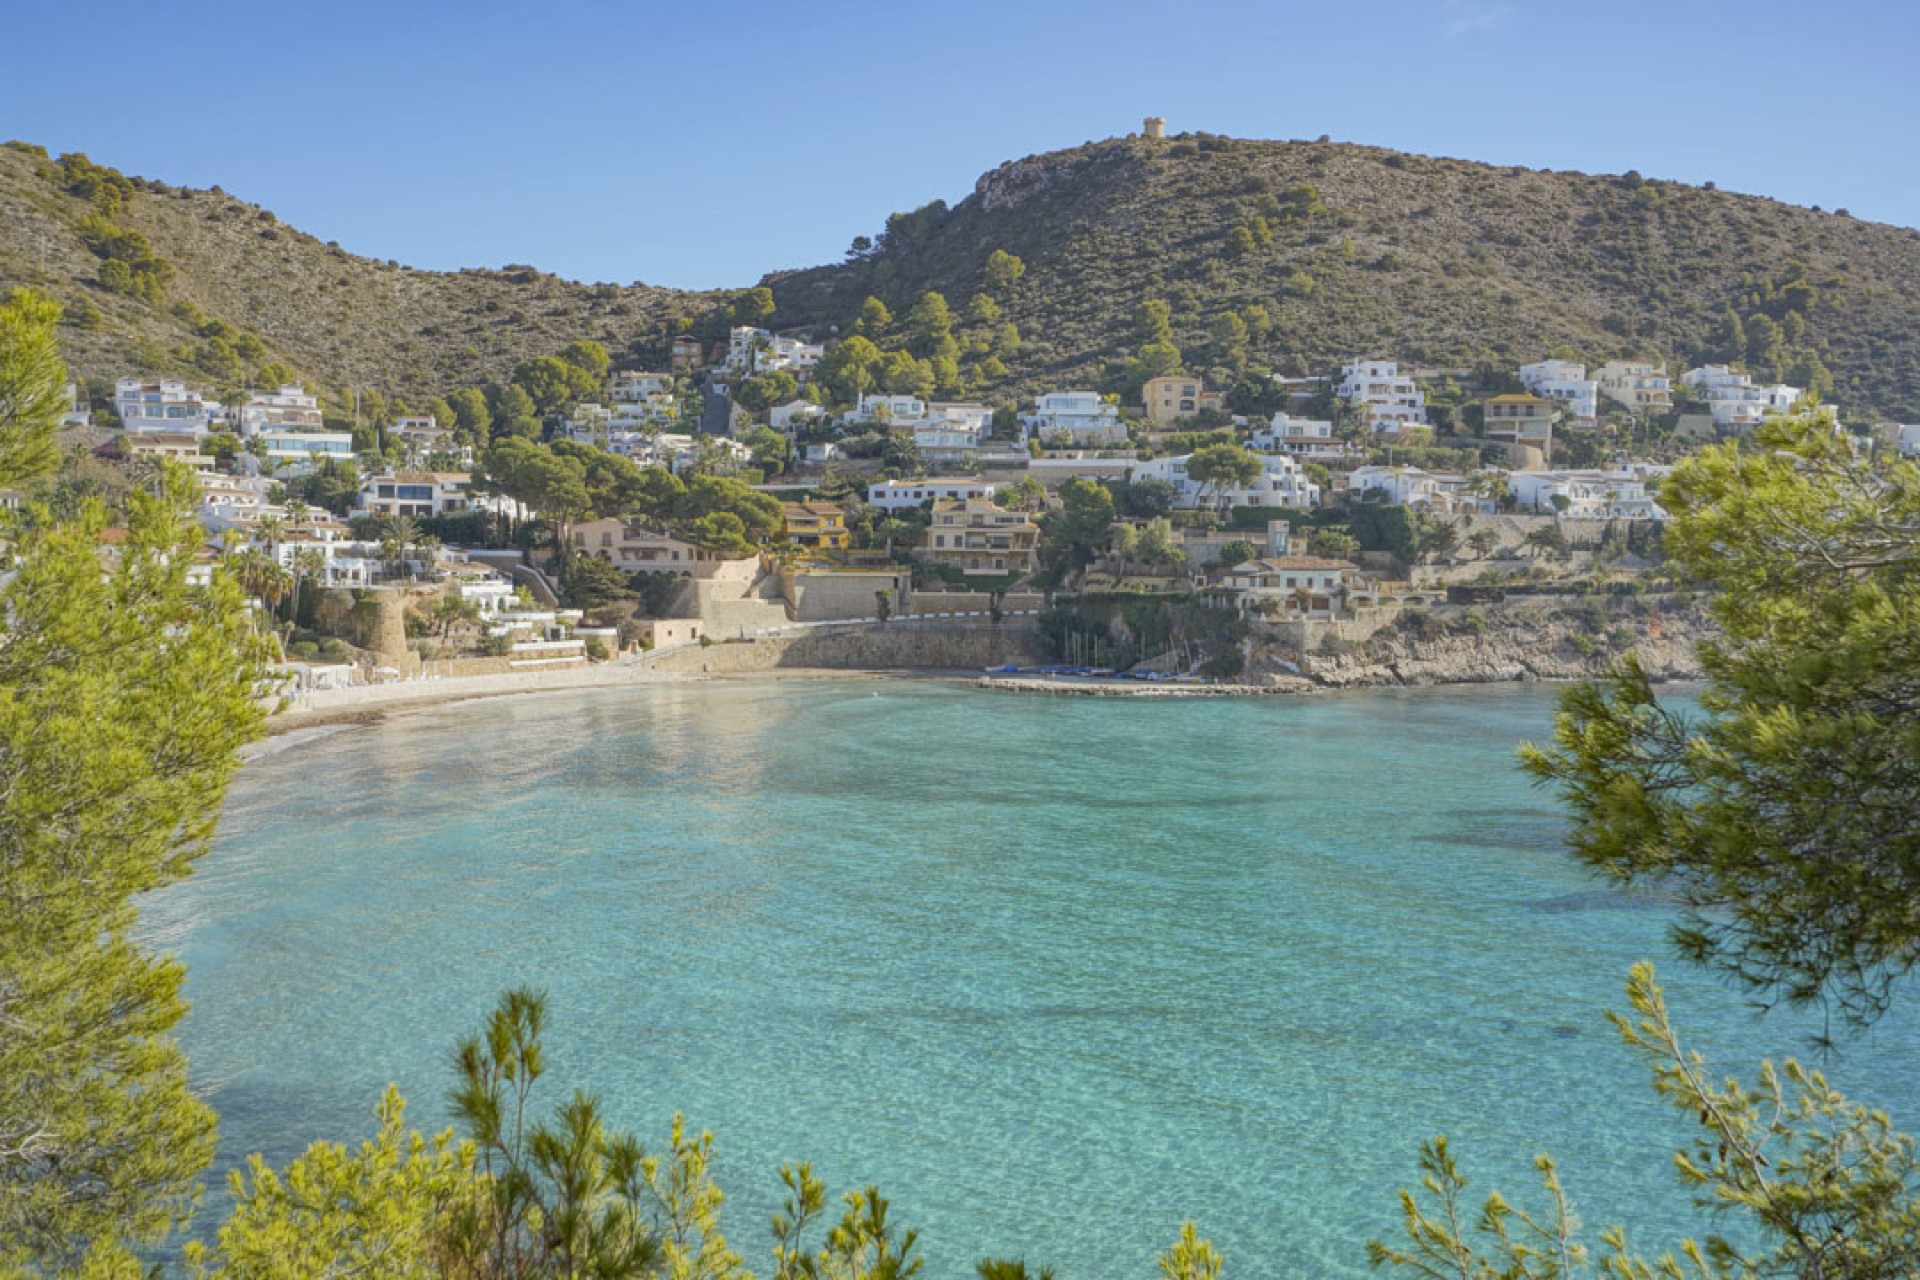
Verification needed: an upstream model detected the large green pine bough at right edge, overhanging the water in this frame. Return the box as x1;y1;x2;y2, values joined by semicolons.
1528;420;1920;1021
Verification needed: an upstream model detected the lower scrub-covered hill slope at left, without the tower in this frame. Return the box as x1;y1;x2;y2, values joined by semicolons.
0;144;716;395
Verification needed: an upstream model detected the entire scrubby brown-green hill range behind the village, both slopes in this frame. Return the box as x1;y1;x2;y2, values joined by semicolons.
0;134;1920;420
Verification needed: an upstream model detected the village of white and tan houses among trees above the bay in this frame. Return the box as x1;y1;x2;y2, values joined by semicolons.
48;297;1920;695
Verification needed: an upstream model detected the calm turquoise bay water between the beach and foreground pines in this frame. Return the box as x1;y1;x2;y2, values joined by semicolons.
148;681;1920;1280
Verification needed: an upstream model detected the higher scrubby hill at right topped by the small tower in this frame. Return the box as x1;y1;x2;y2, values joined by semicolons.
764;136;1920;420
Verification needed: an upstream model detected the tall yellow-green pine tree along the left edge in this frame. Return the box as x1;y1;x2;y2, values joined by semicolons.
0;297;261;1274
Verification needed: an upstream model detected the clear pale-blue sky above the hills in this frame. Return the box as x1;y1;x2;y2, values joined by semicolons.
0;0;1920;288
